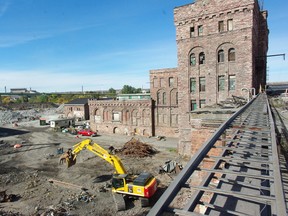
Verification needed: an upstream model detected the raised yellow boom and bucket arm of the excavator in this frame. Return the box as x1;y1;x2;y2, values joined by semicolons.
68;139;127;174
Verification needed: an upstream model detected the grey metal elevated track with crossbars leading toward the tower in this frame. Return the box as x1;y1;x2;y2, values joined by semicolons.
148;94;287;216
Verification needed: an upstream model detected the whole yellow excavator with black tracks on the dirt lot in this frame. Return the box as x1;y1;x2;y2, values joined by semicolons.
66;139;158;211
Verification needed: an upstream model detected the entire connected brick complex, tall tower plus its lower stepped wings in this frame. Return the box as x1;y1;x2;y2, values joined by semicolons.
89;0;269;154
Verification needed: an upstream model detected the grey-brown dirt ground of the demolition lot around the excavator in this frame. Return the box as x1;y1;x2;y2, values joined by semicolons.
0;120;185;216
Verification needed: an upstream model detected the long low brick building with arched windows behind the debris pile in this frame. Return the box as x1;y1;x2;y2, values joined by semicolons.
88;94;154;136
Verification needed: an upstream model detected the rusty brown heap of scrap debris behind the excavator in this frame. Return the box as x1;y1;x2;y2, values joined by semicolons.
116;138;157;158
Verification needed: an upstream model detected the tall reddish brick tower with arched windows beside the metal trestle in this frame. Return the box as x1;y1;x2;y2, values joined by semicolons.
174;0;268;154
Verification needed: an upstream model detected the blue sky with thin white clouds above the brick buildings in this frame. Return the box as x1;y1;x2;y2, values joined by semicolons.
0;0;288;92
